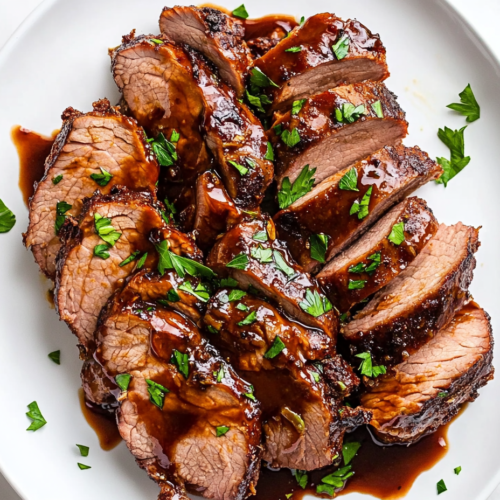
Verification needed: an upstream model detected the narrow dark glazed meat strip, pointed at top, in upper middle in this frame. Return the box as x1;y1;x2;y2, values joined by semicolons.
185;47;274;210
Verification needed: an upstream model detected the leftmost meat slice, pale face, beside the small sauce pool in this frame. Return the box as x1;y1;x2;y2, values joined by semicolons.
24;99;159;279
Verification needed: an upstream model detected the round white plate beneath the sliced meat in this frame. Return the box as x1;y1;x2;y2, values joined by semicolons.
0;0;500;500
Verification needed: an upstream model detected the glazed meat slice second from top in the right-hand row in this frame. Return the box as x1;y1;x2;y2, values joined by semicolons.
269;82;408;185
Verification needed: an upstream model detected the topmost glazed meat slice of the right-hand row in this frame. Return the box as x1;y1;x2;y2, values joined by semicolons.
255;13;389;109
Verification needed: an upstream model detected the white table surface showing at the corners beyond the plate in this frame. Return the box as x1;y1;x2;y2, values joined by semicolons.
0;0;500;500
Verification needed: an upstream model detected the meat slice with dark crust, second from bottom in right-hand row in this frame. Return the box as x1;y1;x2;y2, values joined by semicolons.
342;222;479;365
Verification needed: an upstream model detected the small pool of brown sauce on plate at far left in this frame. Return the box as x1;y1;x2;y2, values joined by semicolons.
11;125;59;206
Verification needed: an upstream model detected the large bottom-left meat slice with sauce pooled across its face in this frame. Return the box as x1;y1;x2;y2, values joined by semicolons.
96;296;261;500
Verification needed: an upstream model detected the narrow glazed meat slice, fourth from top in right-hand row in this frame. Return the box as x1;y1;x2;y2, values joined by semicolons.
317;197;438;312
